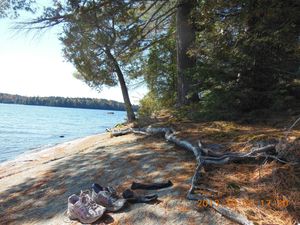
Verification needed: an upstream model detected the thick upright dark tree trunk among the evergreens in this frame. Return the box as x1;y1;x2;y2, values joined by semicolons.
176;0;196;105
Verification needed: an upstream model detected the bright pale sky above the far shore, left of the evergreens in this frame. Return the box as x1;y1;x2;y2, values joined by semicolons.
0;14;147;104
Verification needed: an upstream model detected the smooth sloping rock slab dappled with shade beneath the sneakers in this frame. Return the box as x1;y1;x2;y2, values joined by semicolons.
0;134;233;225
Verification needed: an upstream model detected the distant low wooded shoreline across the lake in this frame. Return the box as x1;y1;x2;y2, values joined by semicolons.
0;93;138;111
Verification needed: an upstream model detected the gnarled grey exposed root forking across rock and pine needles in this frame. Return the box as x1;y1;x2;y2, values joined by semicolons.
111;127;284;225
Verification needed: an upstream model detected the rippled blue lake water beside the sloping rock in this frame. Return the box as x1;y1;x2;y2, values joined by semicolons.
0;103;126;162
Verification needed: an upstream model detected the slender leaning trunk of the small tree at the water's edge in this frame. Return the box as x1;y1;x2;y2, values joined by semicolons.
106;50;135;122
